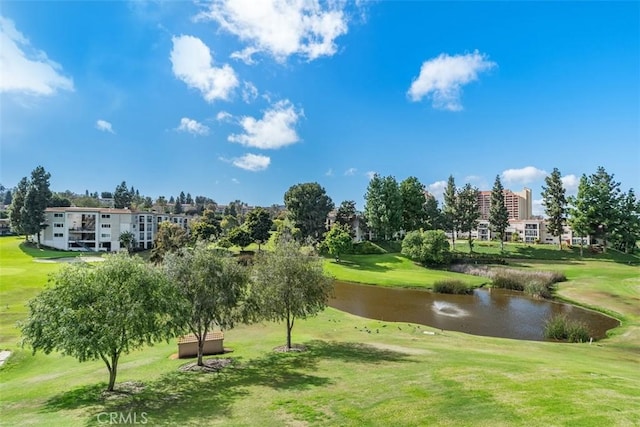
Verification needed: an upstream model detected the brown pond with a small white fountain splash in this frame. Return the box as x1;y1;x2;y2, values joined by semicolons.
329;281;620;341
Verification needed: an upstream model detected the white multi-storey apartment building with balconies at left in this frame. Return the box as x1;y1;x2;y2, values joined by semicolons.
41;207;188;252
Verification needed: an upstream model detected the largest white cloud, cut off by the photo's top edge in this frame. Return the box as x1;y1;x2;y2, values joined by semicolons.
197;0;348;64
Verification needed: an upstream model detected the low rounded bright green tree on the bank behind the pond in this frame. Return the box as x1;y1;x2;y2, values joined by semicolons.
402;230;450;265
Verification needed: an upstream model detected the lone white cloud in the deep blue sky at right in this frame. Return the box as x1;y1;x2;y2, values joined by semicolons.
407;50;497;111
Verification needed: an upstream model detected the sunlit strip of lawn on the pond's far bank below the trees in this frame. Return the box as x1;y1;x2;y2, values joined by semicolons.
324;253;488;288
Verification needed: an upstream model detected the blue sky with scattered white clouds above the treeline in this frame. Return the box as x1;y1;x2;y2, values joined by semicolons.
0;0;640;212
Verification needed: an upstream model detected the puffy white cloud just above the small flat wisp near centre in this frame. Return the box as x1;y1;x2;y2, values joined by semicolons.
228;100;304;150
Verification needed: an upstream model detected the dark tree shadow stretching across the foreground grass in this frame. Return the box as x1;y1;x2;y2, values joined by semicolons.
44;340;416;425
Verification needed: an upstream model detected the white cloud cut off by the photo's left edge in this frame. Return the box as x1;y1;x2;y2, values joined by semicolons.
0;16;73;96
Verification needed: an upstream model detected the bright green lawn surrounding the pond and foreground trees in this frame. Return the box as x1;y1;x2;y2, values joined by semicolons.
0;238;640;426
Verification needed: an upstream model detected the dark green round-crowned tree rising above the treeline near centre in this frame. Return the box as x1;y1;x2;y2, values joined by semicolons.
284;182;334;241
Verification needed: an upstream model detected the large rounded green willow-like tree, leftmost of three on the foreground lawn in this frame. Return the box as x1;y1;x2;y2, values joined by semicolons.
21;254;178;391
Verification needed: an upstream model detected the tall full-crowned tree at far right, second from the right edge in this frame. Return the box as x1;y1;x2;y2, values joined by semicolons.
587;166;620;252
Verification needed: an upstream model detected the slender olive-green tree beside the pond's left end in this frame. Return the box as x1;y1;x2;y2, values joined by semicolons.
253;240;333;350
